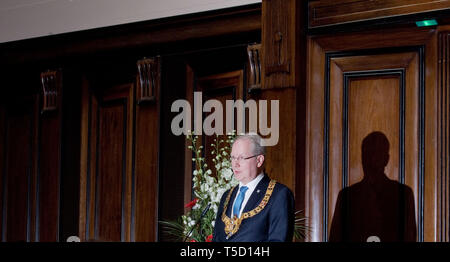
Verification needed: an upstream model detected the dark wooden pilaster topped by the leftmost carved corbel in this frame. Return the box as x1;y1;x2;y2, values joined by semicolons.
36;71;62;242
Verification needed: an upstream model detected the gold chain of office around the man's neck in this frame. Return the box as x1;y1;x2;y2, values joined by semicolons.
222;179;277;239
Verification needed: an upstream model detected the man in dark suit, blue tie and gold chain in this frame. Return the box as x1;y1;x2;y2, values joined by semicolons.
213;134;294;242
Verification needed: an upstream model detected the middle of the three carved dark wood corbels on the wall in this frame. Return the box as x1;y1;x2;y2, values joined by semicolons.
136;57;160;105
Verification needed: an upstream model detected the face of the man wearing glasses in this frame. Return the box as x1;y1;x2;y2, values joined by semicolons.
231;139;264;184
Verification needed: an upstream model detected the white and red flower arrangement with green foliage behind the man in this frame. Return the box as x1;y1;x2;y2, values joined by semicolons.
160;131;309;242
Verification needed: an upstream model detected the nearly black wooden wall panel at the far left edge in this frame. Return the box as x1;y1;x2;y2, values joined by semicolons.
2;95;38;242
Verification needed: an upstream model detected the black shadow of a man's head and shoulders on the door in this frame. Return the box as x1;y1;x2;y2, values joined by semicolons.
329;132;416;242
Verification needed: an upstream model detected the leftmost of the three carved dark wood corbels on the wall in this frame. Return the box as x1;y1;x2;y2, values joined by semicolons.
41;70;61;114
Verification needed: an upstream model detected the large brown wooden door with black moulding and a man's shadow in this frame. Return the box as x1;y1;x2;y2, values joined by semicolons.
306;30;440;241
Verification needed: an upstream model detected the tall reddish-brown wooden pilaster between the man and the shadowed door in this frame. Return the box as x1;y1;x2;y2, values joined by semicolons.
260;1;307;217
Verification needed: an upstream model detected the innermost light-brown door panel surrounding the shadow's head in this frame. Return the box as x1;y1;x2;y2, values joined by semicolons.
348;77;400;185
